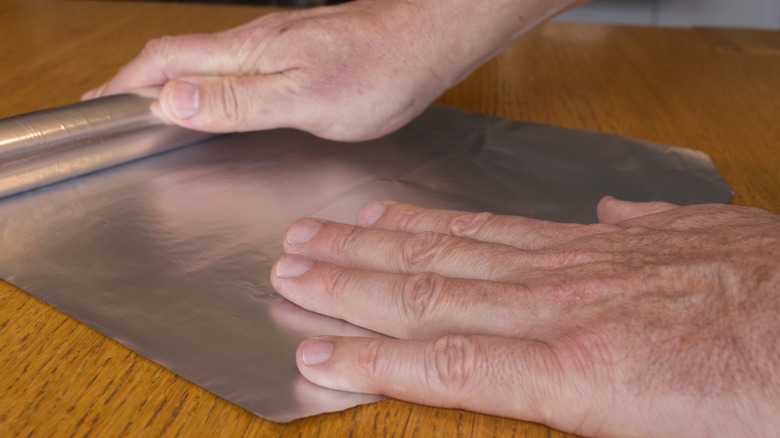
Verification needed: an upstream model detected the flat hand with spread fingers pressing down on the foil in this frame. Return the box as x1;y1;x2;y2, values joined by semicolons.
271;198;780;436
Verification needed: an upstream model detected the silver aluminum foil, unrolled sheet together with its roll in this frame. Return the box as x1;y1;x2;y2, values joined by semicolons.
0;96;731;421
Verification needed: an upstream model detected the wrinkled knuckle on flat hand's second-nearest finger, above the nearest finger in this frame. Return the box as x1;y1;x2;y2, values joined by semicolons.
398;272;446;327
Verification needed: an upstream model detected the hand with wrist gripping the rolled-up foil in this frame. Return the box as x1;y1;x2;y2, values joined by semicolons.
83;0;582;140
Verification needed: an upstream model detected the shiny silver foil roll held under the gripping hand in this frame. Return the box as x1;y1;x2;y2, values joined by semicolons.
0;95;211;197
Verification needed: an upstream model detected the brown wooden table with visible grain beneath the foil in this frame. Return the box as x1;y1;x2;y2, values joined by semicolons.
0;0;780;436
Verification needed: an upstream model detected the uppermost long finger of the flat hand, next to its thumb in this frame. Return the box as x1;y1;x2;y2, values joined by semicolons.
357;201;613;250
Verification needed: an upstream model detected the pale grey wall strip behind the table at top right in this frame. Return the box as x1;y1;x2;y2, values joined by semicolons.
559;0;780;29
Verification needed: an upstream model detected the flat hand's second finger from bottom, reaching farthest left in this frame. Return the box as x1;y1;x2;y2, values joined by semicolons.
271;255;556;338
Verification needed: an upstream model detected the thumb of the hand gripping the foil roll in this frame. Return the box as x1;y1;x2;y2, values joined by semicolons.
152;74;298;132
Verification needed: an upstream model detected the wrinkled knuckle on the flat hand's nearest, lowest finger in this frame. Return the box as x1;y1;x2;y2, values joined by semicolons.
425;335;478;395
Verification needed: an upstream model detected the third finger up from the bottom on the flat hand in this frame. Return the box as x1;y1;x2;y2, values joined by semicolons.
284;219;612;281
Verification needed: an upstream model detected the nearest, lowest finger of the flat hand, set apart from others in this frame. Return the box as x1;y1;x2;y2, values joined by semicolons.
296;336;596;433
